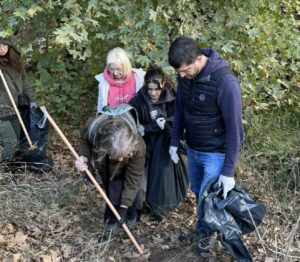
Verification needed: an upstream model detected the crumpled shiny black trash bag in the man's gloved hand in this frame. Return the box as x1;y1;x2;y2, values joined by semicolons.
199;179;266;262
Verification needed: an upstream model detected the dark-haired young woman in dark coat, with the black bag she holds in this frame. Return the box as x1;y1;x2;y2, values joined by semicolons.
130;66;187;217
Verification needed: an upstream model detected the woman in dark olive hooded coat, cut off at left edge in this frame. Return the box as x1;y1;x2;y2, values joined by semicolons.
0;37;36;161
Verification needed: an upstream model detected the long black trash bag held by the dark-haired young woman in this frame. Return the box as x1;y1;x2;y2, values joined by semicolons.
146;131;189;219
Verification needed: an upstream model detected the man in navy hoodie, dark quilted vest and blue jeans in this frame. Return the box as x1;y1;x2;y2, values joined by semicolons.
168;36;243;253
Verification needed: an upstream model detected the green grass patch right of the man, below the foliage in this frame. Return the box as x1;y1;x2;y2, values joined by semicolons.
240;108;300;201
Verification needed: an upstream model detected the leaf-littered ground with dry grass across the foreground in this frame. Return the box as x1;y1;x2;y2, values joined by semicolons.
0;149;300;262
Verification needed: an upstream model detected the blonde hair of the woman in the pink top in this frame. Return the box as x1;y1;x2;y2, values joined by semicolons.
106;47;132;76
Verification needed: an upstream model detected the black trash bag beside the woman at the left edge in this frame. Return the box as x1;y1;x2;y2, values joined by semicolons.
17;107;53;173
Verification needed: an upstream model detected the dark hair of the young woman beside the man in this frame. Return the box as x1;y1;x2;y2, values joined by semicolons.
144;65;174;90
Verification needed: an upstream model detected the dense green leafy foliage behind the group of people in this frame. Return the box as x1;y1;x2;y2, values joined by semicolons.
0;0;300;127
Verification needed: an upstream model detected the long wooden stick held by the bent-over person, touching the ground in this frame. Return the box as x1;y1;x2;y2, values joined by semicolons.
40;106;144;254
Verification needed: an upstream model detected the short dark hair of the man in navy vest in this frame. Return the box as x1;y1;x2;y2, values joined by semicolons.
168;36;202;69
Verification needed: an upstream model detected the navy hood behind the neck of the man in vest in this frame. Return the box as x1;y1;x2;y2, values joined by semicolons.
199;48;228;77
